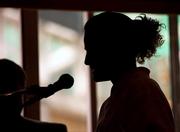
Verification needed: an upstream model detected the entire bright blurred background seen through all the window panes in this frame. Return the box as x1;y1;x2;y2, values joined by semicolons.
0;8;175;132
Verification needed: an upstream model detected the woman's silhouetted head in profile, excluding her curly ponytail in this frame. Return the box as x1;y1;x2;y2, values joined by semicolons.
84;12;135;82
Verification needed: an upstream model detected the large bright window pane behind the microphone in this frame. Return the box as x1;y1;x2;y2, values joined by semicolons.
39;10;89;132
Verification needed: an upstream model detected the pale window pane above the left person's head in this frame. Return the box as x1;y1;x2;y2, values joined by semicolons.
0;8;22;65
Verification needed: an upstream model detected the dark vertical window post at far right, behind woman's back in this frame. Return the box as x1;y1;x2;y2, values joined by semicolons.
169;14;180;132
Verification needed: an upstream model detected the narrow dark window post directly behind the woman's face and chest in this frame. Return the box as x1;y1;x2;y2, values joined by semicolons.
88;12;97;132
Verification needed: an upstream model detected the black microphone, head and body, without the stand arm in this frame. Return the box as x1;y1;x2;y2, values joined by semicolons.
26;74;74;98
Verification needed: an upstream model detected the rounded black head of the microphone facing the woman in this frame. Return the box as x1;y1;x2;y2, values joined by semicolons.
54;74;74;89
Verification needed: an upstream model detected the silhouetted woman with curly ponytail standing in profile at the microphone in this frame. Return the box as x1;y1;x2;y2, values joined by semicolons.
84;12;174;132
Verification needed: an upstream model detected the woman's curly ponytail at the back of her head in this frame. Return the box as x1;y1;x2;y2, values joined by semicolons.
133;14;165;64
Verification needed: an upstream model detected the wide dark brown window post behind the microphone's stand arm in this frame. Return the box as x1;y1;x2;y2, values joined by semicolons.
21;9;40;119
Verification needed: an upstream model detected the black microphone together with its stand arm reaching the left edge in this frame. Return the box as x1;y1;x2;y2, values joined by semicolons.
0;74;74;107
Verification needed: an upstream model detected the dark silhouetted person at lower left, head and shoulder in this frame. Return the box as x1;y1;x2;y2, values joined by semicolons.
0;59;67;132
